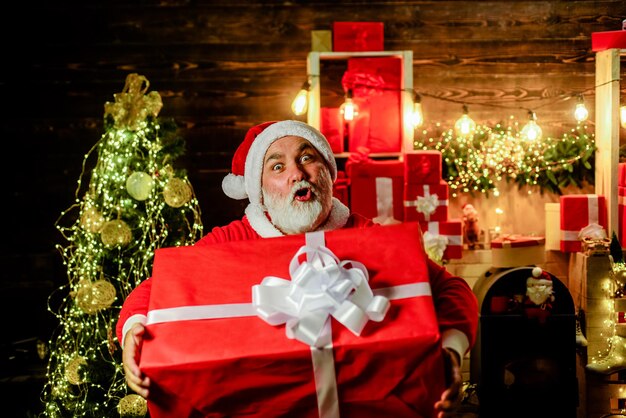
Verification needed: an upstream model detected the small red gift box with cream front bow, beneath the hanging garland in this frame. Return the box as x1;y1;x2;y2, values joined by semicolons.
404;180;448;222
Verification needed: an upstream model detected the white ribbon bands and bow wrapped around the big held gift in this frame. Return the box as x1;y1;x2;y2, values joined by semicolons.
148;231;432;418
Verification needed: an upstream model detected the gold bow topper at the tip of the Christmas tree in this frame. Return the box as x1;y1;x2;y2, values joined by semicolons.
104;73;163;130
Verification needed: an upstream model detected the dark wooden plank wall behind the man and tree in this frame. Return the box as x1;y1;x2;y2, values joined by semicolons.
0;0;626;352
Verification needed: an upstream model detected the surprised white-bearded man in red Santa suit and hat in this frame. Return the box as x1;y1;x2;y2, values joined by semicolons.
116;120;478;418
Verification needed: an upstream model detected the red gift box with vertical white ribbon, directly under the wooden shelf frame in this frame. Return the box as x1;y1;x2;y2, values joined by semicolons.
346;158;404;223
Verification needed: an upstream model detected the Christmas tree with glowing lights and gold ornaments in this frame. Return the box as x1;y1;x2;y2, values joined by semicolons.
42;74;202;418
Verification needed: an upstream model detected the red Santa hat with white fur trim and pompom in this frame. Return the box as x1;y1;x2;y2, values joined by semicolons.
222;120;349;237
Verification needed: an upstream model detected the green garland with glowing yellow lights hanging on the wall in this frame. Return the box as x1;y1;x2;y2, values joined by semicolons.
414;124;596;197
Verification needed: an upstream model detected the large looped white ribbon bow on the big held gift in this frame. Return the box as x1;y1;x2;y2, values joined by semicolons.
252;245;390;347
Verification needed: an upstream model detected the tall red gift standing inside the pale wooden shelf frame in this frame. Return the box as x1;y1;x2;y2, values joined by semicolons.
342;57;402;153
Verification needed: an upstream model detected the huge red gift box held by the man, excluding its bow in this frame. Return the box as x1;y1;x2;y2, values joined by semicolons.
140;223;445;418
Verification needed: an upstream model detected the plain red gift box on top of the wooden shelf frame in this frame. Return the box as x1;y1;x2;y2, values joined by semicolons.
333;22;385;52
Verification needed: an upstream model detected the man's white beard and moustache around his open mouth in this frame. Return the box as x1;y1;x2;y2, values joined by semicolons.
262;170;332;234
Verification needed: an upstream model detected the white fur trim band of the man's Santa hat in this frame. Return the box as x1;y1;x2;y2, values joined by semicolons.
244;120;337;204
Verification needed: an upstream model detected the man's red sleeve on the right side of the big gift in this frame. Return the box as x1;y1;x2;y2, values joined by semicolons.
428;259;478;347
